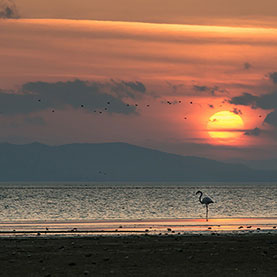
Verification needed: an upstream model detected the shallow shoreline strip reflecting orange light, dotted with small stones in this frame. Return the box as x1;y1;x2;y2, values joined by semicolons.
0;217;277;237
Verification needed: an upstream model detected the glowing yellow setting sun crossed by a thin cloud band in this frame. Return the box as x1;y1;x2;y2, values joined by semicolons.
207;111;244;141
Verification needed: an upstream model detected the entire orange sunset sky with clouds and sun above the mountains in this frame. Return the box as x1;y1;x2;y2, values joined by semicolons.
0;0;277;160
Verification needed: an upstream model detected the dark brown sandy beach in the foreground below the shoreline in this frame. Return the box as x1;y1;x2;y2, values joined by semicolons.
0;233;277;277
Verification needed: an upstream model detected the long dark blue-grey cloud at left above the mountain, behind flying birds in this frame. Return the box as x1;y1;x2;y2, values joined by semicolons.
0;80;146;115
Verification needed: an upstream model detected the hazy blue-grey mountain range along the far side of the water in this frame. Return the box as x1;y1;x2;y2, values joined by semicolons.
0;143;277;182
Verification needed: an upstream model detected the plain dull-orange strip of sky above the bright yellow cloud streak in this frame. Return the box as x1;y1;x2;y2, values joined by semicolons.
16;0;277;26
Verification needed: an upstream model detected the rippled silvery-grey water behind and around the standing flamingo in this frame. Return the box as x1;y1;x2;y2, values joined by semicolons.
0;183;277;222
